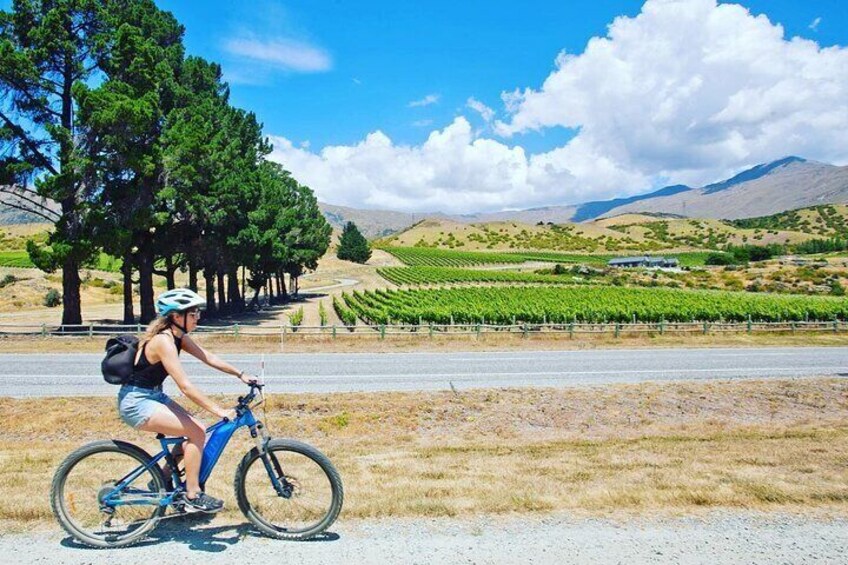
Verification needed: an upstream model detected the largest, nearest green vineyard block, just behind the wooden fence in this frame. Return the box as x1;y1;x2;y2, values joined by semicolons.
343;286;848;324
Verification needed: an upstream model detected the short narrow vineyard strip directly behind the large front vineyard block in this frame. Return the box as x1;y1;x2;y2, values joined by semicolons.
377;267;579;285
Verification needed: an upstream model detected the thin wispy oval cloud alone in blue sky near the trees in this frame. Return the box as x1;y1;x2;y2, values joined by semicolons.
224;37;333;73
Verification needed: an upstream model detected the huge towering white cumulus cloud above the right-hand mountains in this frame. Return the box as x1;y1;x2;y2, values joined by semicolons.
496;0;848;187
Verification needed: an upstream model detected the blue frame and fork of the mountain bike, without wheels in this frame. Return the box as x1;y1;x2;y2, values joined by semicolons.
101;399;284;507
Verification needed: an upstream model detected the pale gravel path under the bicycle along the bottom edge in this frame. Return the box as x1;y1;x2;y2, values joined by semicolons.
0;512;848;565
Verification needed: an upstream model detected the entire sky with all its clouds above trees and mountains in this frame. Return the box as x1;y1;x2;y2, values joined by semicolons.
0;0;848;212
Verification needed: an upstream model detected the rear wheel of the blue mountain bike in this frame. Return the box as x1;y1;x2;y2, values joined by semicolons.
50;440;165;547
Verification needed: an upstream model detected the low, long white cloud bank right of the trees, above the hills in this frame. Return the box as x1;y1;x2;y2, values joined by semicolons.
270;117;645;212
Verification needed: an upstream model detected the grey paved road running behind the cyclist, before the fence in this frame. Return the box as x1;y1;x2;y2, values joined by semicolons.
0;347;848;396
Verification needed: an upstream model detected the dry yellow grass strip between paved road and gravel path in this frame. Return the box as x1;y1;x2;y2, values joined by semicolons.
0;378;848;530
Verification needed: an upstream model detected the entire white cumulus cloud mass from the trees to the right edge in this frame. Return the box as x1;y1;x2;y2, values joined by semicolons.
264;0;848;212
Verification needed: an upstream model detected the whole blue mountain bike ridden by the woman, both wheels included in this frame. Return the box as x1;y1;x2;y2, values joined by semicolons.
50;384;344;547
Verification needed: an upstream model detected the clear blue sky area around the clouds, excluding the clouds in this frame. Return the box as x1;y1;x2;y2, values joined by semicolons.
158;0;848;153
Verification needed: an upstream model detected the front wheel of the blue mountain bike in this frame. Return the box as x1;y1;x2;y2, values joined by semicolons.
235;439;344;540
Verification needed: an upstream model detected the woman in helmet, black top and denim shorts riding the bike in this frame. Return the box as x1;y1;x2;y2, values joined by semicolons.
118;288;257;512
